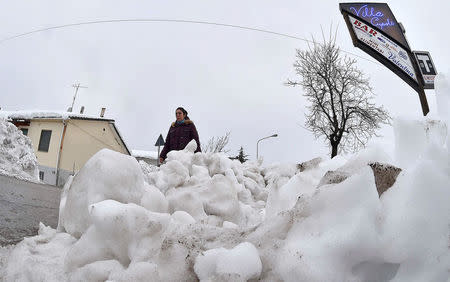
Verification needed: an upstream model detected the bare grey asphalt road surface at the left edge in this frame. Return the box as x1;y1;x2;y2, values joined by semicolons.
0;175;61;246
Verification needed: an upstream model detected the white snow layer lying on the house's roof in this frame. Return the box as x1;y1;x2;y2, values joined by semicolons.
0;110;111;120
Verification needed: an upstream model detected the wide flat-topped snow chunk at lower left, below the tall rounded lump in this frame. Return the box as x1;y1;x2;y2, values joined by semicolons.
65;200;170;271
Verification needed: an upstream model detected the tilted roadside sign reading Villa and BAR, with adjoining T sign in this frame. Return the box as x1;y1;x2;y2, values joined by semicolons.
339;3;434;116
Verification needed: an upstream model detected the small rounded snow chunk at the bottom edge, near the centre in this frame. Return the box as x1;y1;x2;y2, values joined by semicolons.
194;242;262;281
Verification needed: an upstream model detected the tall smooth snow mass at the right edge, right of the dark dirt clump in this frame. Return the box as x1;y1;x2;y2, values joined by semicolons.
381;145;450;281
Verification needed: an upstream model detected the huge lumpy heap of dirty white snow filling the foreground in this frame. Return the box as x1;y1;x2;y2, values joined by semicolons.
0;74;450;281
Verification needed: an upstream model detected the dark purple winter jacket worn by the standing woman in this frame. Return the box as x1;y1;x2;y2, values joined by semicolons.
159;119;202;160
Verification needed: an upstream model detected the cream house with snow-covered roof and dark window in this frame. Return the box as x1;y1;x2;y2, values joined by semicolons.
0;111;130;186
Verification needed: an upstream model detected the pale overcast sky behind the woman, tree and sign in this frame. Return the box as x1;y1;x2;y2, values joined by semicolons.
0;0;450;162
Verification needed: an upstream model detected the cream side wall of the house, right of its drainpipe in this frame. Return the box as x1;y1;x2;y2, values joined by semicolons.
59;119;128;172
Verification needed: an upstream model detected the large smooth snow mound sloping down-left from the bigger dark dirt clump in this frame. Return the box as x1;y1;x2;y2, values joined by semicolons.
276;167;379;281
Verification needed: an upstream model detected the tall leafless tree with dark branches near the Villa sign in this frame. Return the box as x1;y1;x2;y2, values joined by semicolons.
286;36;390;158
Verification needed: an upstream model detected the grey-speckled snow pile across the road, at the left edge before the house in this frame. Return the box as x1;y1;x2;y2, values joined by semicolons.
0;118;39;182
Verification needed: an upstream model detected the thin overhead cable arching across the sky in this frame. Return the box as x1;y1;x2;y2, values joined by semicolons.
0;19;379;65
